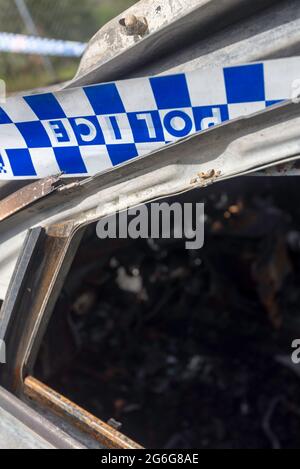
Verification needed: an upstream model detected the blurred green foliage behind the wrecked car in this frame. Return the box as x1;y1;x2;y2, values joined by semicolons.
0;0;136;91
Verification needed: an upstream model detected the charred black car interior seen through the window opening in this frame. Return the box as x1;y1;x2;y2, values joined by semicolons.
35;178;300;448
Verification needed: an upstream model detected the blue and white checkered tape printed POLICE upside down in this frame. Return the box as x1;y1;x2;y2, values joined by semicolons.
0;57;300;179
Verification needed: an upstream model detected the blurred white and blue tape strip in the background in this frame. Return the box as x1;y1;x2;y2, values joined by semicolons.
0;33;86;57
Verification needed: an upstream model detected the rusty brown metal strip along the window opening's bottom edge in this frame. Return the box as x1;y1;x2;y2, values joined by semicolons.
24;376;143;449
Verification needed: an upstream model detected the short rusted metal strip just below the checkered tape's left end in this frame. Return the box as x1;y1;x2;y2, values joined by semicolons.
0;175;60;222
